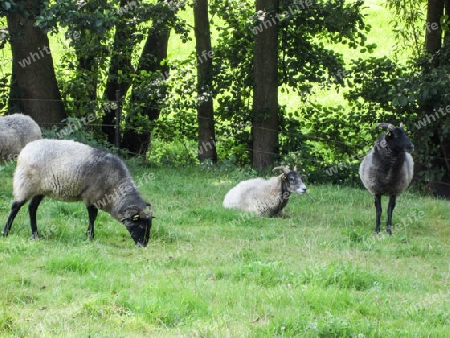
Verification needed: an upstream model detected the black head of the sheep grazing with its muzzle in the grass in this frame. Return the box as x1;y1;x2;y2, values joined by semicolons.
122;204;153;248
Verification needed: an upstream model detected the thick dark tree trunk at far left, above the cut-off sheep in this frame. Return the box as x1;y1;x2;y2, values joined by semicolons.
7;0;66;128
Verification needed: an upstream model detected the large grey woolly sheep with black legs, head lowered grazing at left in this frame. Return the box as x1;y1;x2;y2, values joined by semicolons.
3;140;153;247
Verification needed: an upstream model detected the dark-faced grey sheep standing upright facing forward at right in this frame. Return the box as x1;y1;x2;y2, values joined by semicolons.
359;123;414;235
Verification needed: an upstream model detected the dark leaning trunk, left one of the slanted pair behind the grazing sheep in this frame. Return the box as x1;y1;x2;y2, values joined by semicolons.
102;0;135;144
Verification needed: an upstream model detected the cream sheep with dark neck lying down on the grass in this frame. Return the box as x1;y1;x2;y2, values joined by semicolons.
223;167;306;217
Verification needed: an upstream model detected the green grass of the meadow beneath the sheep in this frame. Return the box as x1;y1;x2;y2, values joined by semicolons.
0;165;450;337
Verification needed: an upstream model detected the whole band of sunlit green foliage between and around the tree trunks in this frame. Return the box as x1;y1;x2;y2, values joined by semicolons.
0;0;450;190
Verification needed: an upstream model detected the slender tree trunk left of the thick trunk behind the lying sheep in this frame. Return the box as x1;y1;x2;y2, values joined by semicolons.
194;0;217;163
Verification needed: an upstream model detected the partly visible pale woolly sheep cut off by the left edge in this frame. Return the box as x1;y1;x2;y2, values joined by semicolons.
0;114;42;161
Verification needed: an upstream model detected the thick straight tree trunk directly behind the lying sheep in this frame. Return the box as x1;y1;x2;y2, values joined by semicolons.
252;0;279;169
